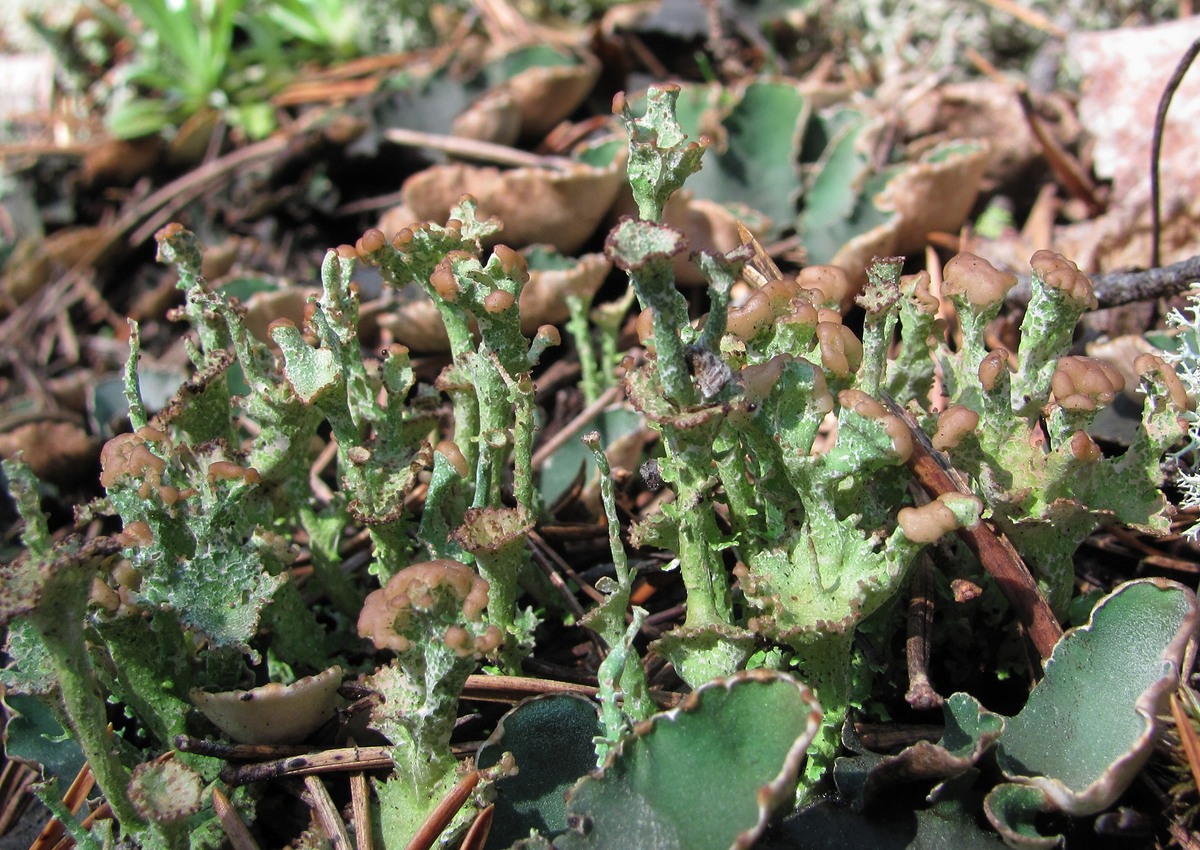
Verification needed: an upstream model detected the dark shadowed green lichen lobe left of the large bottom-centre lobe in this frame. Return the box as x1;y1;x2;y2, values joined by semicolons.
475;694;601;848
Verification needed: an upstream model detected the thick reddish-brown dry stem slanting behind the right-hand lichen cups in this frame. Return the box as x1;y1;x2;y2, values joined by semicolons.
883;394;1062;663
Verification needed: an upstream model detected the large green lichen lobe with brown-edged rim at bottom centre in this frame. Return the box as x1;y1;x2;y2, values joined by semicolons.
554;669;821;850
